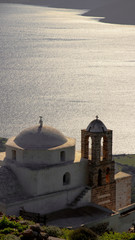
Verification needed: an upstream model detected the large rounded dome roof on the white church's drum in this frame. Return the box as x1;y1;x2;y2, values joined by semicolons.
14;125;67;149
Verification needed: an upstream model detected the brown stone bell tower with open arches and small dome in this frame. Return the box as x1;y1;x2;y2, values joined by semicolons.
81;116;116;210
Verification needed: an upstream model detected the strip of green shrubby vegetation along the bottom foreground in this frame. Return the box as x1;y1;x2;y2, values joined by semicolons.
0;215;135;240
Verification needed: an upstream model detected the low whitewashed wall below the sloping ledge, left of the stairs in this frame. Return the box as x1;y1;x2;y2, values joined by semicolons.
4;187;83;215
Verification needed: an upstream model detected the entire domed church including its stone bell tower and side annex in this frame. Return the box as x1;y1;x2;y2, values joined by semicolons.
0;117;134;232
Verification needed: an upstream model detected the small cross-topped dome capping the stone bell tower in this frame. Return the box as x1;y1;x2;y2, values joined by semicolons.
86;116;107;133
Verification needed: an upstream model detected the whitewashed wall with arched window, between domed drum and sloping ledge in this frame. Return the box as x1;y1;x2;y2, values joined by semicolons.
6;158;88;196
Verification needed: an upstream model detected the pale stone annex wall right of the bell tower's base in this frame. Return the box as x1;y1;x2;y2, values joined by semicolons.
116;176;131;210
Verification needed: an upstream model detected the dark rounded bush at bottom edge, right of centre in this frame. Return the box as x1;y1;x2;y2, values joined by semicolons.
69;227;97;240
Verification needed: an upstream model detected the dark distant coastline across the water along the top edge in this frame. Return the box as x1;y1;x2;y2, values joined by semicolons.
0;0;135;25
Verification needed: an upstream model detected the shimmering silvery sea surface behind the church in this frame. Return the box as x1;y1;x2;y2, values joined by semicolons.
0;3;135;154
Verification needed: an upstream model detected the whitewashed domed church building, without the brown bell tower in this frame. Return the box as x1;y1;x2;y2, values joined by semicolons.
0;117;90;214
